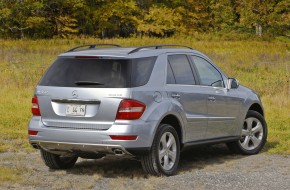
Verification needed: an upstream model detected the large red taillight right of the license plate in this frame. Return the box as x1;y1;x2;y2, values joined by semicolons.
116;100;146;120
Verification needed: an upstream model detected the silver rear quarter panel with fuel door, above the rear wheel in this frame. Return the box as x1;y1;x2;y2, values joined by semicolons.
131;54;185;142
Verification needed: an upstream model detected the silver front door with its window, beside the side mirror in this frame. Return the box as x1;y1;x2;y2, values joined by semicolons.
191;56;240;139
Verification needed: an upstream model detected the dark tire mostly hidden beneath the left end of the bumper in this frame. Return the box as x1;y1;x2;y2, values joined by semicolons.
40;149;78;169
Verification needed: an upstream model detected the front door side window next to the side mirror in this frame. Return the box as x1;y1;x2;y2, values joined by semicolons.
192;56;224;87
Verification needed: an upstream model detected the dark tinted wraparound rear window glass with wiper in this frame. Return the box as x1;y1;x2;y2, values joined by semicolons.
39;57;156;88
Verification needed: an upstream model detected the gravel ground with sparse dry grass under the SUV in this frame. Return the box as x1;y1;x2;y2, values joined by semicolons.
0;145;290;190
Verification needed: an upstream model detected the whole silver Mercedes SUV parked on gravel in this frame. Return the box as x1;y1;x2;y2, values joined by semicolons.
28;44;267;176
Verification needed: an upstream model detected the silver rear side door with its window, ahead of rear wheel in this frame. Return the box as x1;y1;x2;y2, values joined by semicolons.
166;54;207;142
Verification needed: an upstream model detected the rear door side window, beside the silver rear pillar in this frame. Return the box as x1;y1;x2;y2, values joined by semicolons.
167;55;195;85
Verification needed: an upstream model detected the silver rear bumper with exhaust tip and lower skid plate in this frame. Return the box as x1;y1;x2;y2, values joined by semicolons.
28;116;157;155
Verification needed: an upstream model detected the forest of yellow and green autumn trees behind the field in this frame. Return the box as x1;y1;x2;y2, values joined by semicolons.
0;0;290;39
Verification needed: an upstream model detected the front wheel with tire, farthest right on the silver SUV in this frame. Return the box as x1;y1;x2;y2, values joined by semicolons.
227;110;267;155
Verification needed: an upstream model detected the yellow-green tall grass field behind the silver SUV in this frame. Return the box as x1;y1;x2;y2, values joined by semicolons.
0;36;290;154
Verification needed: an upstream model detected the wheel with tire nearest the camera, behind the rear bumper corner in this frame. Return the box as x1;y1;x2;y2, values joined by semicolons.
141;124;180;176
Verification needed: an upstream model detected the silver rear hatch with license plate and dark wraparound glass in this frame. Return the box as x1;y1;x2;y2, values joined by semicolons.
36;57;156;130
